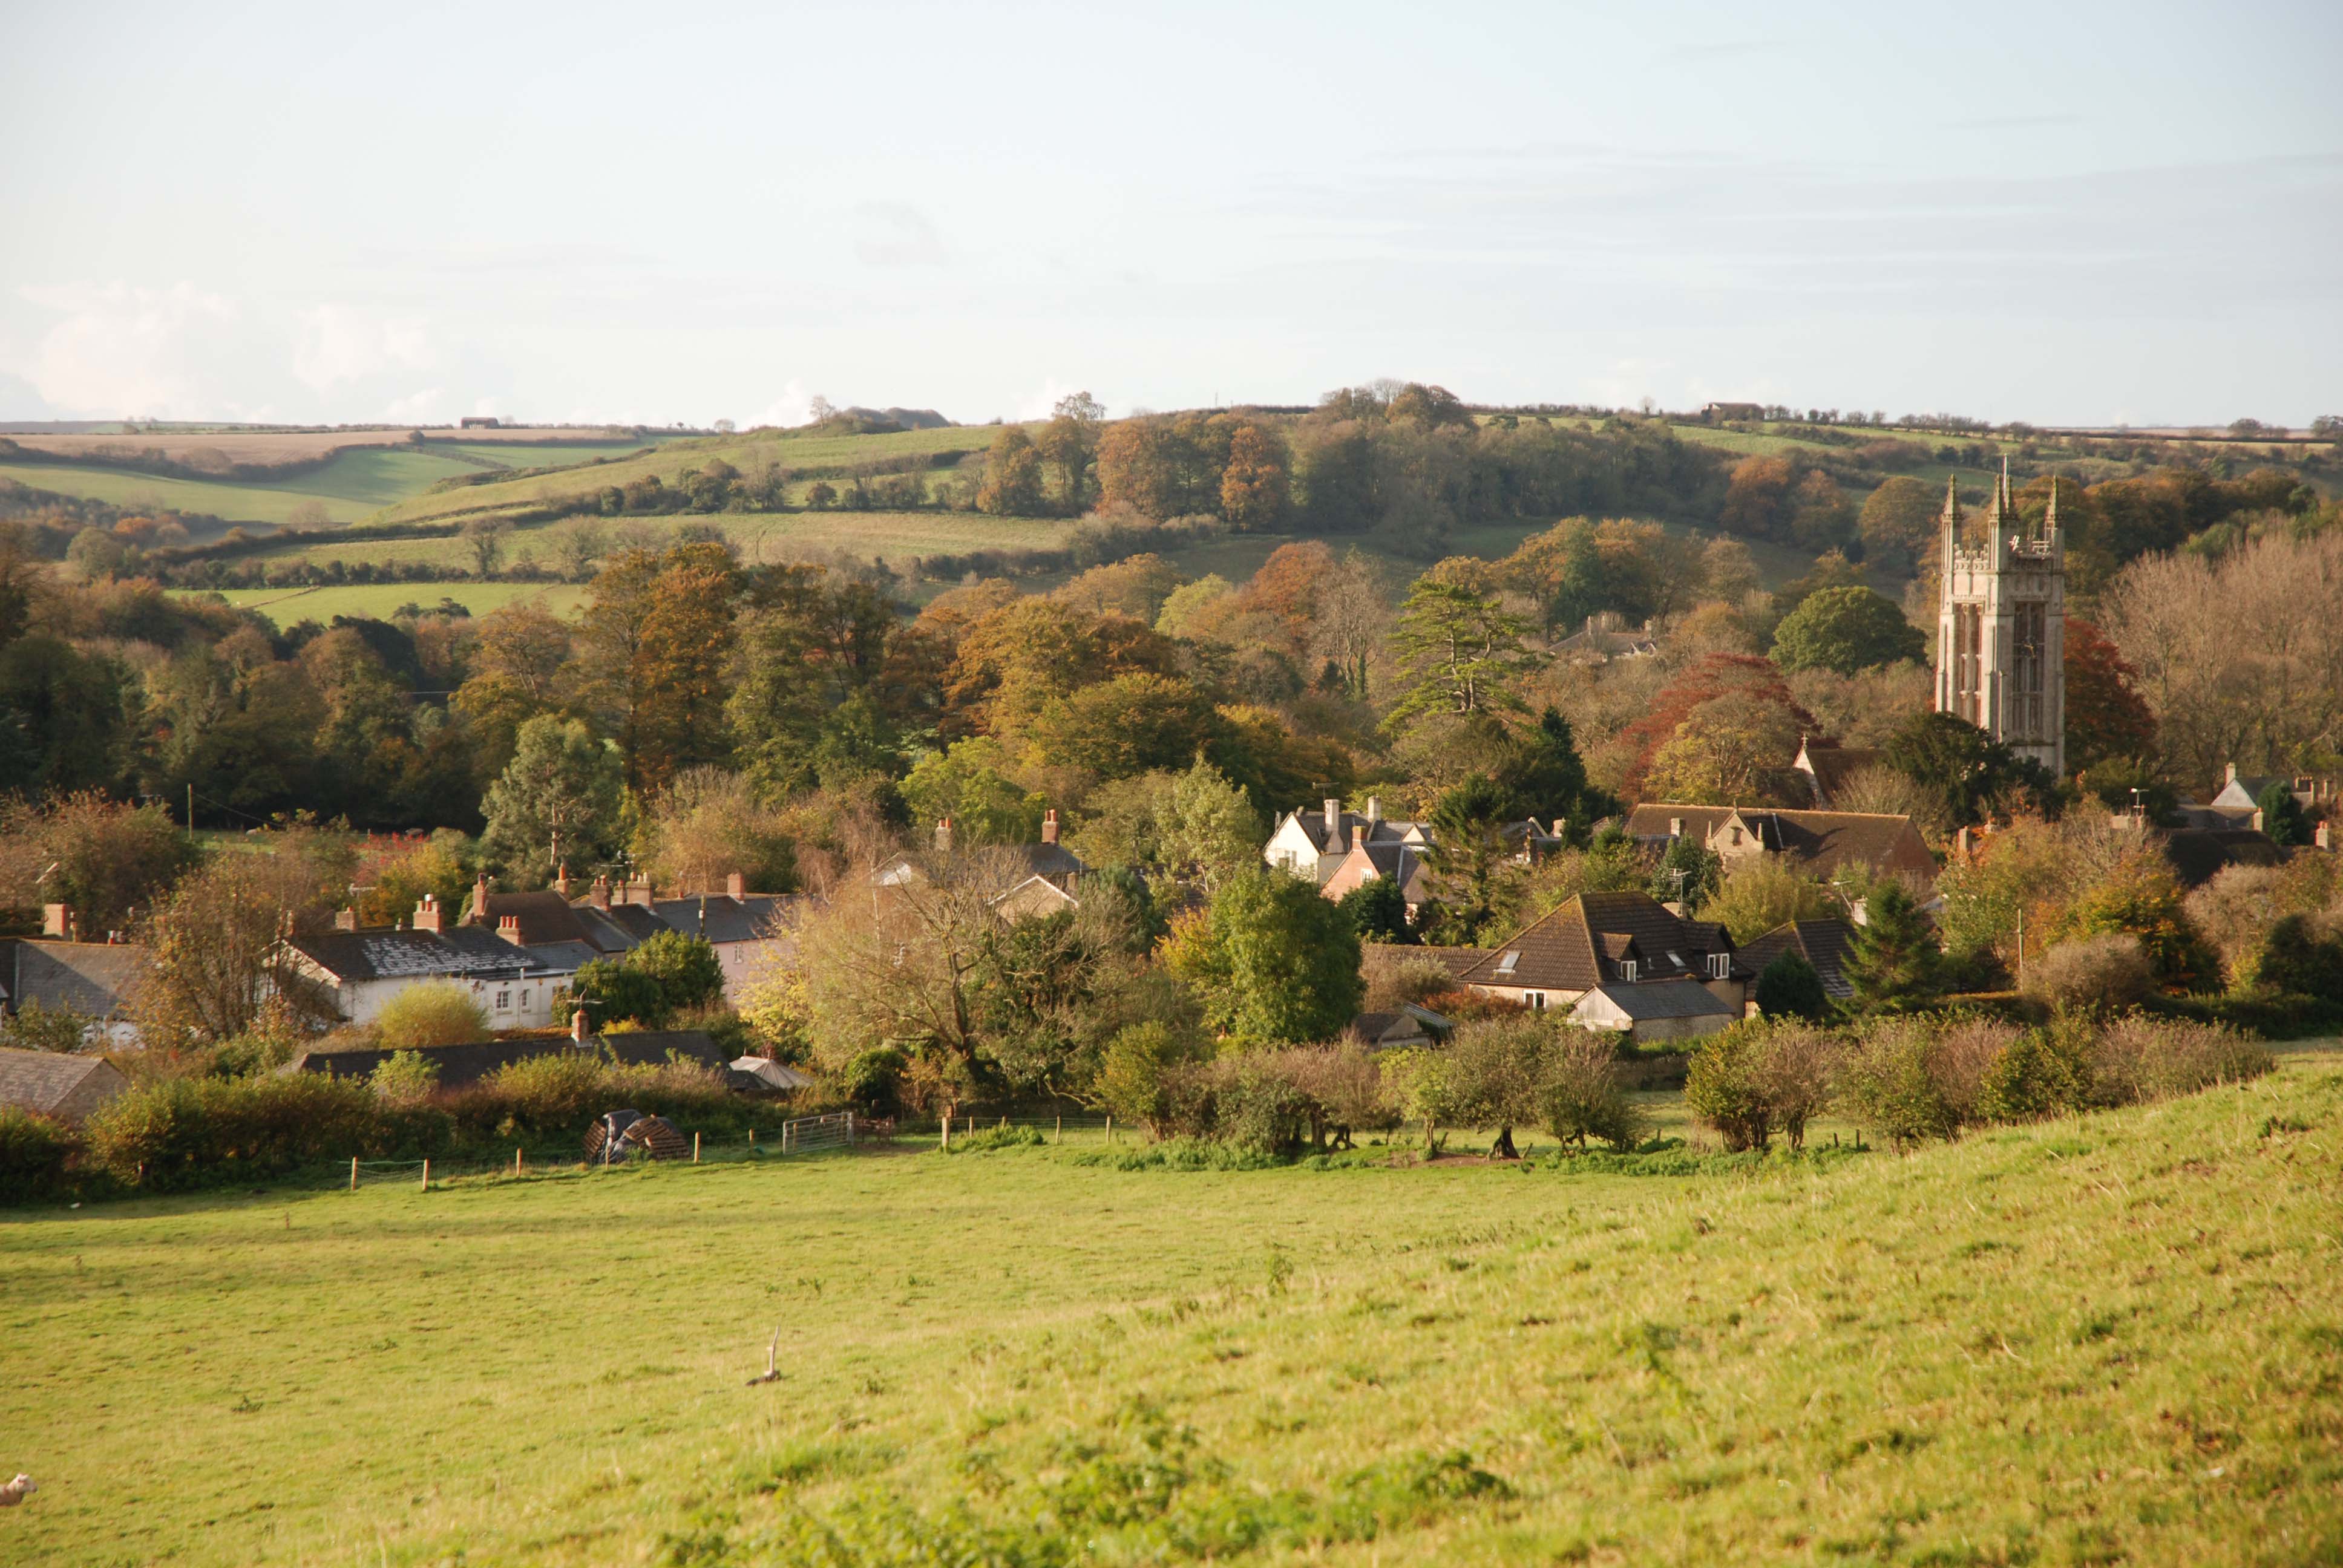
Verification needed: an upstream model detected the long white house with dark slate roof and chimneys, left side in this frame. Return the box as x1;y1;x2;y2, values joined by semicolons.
284;893;577;1029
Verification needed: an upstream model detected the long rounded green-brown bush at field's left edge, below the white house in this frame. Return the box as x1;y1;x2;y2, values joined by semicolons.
84;1073;448;1191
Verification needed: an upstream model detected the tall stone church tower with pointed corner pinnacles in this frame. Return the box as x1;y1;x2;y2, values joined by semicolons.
1935;462;2066;778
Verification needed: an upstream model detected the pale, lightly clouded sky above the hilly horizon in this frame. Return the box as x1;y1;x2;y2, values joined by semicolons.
0;0;2343;426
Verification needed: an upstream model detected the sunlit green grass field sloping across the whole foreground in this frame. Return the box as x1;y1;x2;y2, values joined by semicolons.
0;1053;2343;1566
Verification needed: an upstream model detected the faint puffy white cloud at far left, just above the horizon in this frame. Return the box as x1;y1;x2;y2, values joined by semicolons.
7;281;251;420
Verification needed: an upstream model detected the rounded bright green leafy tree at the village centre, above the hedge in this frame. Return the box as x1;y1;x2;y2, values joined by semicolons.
1162;869;1366;1043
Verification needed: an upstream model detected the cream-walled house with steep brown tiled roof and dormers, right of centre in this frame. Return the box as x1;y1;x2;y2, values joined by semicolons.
1460;893;1755;1040
